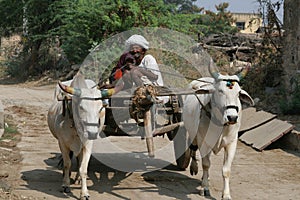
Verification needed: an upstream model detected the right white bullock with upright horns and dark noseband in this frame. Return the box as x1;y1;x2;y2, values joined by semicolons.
183;60;254;200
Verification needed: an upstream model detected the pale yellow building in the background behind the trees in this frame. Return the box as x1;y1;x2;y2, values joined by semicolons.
231;13;262;33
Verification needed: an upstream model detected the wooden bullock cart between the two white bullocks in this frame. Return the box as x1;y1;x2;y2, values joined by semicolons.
103;86;195;169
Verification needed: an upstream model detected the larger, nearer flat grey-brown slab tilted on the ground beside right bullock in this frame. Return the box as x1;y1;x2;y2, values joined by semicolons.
239;119;294;151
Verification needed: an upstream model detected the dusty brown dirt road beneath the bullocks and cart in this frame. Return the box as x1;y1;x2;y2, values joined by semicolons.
0;80;300;200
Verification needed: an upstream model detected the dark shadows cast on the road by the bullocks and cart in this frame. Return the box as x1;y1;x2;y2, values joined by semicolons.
22;153;214;200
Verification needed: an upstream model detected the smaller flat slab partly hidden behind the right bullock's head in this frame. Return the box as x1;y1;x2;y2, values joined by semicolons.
239;107;276;133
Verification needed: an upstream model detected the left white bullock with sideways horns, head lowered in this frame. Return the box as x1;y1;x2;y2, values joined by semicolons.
48;73;114;199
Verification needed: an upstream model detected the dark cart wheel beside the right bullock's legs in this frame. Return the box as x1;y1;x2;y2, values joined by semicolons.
173;130;191;170
